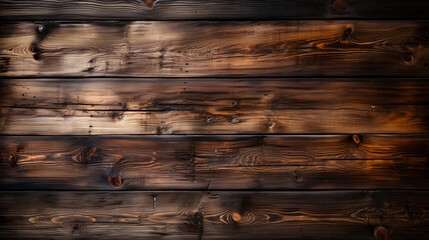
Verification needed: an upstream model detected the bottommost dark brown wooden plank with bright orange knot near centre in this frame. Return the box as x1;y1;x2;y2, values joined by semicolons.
0;191;429;240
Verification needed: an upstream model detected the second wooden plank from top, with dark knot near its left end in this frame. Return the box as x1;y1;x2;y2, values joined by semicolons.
0;21;429;77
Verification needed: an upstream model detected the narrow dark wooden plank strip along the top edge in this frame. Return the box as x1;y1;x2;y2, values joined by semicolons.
0;0;429;20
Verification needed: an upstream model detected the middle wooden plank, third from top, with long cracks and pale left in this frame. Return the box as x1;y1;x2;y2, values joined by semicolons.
0;78;429;135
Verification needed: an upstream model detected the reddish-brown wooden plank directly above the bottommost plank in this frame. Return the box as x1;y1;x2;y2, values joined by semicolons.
0;135;429;190
